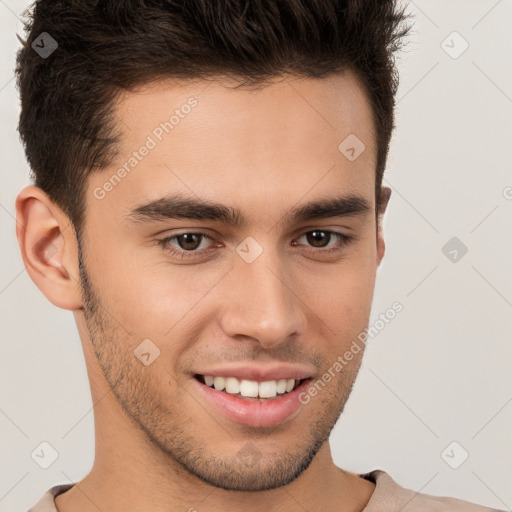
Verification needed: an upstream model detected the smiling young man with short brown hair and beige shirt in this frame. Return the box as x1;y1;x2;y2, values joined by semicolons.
16;0;504;512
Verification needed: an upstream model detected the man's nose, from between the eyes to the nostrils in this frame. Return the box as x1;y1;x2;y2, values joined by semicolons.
220;243;306;349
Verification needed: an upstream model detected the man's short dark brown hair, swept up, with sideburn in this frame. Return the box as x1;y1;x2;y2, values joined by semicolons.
15;0;409;236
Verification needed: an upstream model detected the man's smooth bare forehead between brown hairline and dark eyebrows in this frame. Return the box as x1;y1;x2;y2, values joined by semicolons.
88;72;376;222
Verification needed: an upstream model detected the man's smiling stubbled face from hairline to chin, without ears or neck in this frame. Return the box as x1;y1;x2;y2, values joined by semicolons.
80;74;383;490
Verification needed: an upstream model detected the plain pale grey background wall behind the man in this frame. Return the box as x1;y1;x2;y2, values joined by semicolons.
0;0;512;511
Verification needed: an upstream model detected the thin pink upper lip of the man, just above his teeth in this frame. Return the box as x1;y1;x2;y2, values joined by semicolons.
194;364;313;382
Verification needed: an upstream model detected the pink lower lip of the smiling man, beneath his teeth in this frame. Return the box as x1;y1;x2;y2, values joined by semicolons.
192;378;311;427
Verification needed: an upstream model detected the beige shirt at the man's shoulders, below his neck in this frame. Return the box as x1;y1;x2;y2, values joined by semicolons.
28;469;505;512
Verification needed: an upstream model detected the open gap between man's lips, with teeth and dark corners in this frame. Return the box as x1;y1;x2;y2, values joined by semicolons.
194;374;310;402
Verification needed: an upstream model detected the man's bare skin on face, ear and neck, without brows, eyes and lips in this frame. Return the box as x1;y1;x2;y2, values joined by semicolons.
16;69;389;512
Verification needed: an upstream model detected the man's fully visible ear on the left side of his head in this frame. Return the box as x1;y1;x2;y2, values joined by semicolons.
16;185;82;310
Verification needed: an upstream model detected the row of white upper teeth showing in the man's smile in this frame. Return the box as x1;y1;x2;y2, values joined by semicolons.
204;375;302;398
